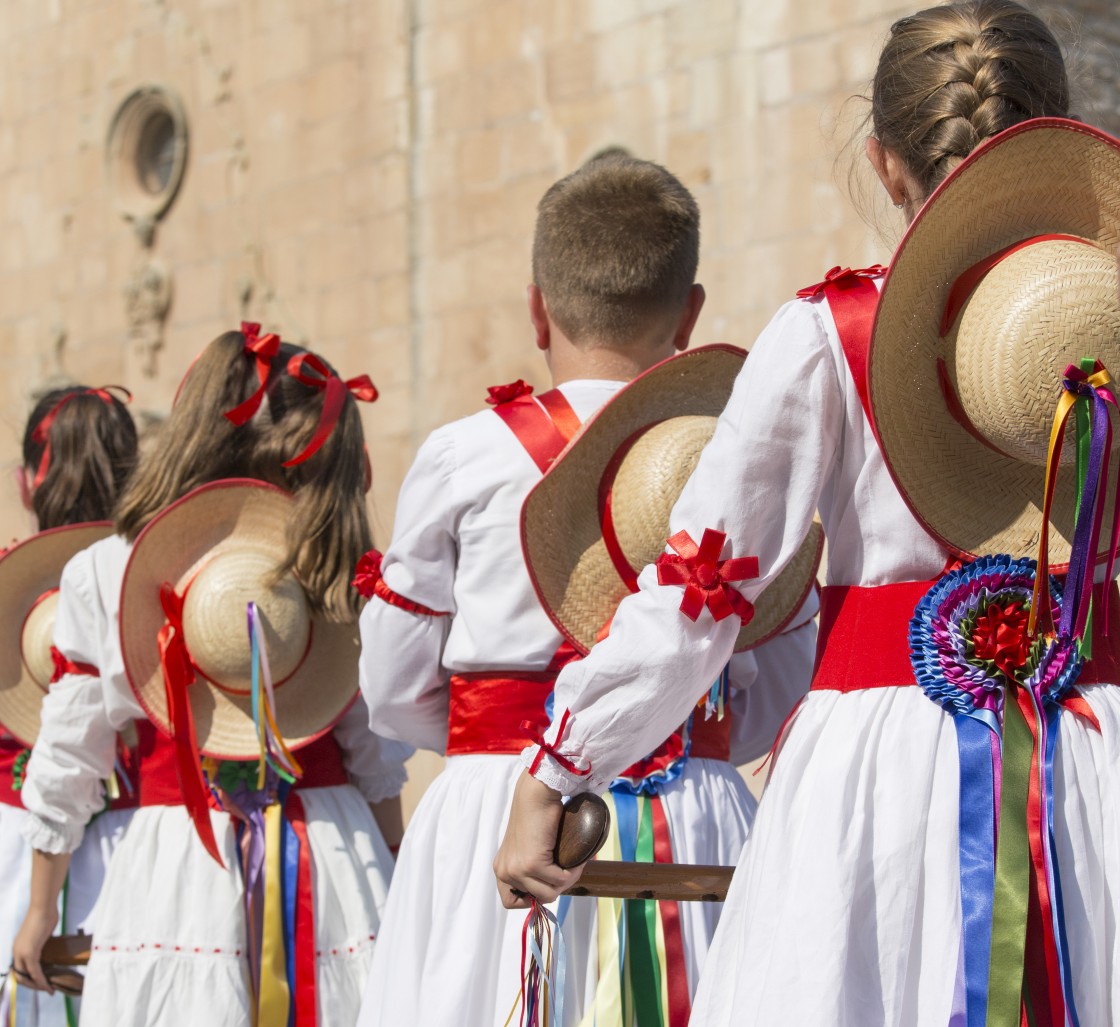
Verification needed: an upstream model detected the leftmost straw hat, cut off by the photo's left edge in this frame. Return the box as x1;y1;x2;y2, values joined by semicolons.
0;521;113;747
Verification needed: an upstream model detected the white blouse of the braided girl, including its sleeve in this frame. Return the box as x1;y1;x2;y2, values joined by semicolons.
523;298;946;794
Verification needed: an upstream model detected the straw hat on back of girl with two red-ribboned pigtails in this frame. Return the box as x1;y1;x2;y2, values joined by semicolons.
121;479;358;759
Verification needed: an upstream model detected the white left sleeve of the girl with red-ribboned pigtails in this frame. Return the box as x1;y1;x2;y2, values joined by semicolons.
21;550;116;852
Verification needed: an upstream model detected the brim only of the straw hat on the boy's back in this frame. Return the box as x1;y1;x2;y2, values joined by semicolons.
521;345;824;653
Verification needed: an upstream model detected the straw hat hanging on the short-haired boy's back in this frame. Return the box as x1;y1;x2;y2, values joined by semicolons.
521;346;824;653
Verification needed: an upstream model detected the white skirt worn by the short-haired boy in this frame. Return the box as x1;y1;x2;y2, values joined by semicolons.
358;756;755;1027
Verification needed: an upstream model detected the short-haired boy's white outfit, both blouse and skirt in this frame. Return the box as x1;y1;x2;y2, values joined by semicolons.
360;382;815;1027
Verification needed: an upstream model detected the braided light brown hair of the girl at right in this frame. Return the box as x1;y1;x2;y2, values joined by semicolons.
871;0;1070;195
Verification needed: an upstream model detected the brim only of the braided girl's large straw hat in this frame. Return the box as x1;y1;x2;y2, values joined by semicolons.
868;119;1120;559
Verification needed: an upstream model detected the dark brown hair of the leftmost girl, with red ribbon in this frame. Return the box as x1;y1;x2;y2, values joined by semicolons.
24;385;137;531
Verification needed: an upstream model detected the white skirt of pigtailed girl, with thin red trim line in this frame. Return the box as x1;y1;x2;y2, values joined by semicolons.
81;785;392;1027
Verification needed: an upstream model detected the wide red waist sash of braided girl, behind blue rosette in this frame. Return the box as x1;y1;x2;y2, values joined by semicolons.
812;581;1120;692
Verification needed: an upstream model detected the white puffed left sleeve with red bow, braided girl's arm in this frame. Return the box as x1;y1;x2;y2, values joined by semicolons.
523;301;844;794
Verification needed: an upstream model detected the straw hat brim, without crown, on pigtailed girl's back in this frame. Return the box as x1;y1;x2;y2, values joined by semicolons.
120;479;360;759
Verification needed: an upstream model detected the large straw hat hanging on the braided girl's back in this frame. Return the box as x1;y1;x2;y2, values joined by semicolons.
868;119;1120;559
